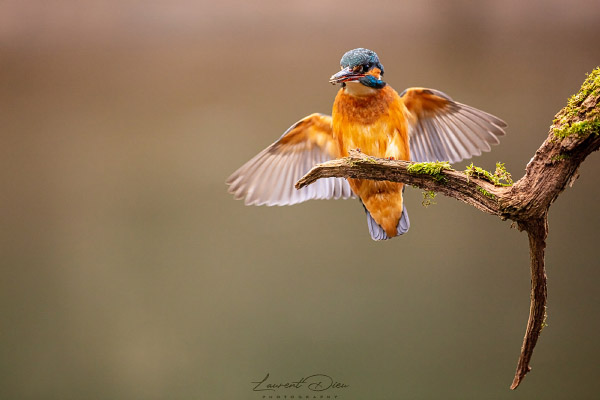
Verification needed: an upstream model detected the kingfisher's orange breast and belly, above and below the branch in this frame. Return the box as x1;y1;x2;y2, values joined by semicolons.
332;86;410;237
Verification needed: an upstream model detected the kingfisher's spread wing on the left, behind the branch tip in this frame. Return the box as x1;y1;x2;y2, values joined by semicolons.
226;114;353;206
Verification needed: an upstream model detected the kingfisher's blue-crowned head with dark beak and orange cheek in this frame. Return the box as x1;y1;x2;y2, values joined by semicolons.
329;48;385;89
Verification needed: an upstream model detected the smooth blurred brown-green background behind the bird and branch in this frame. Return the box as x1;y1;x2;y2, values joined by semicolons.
0;0;600;400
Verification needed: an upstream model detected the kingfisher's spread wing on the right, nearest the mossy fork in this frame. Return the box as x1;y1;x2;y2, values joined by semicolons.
400;88;506;163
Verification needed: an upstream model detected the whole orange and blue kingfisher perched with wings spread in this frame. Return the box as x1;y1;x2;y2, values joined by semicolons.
227;48;507;240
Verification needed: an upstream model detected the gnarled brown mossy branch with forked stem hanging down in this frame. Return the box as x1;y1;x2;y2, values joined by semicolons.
296;68;600;389
